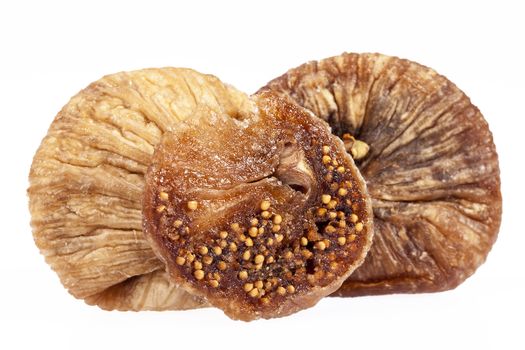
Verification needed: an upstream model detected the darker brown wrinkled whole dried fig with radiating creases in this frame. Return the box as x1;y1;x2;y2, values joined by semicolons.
262;54;501;296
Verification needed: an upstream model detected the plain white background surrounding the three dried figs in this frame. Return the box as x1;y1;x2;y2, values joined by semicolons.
0;0;525;349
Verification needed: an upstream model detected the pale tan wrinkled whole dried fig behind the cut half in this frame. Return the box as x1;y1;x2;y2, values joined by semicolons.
28;68;248;310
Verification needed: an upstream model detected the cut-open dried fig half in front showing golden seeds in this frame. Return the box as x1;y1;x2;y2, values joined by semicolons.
143;93;372;320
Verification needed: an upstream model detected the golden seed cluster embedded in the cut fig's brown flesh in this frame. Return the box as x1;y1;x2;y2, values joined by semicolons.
151;145;364;303
